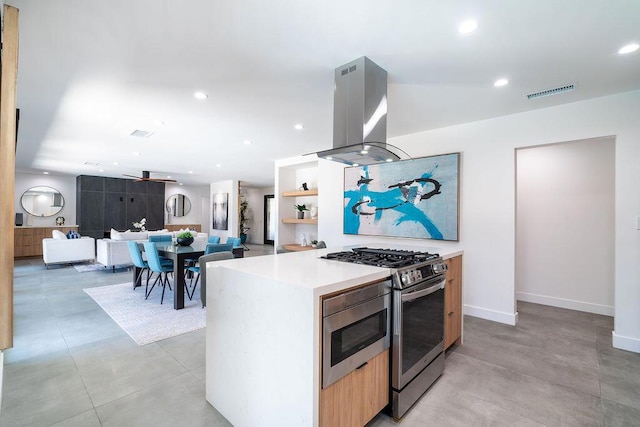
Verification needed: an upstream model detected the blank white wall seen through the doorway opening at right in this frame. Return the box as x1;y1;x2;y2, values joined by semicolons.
516;138;615;316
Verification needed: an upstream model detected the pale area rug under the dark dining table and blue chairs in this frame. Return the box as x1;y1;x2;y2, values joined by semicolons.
83;282;206;345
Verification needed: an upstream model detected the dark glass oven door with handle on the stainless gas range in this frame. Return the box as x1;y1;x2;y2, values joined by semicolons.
391;276;446;390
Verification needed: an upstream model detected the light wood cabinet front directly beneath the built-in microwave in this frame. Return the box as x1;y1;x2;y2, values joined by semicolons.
320;349;389;427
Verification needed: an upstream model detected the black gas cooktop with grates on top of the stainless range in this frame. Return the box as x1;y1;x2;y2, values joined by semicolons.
321;248;440;268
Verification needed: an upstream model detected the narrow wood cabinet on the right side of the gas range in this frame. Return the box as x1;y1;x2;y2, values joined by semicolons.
444;255;462;349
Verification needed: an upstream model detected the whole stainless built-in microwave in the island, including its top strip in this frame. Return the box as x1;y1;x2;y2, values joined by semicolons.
322;280;391;388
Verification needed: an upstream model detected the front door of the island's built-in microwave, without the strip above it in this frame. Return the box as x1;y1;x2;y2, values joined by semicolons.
322;293;391;388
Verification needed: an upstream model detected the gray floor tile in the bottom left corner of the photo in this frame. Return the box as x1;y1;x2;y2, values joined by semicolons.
0;349;93;426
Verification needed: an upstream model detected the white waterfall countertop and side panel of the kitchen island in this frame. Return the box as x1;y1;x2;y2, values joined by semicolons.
206;244;461;427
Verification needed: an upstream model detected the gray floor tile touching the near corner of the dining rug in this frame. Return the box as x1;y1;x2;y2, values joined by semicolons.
70;336;186;406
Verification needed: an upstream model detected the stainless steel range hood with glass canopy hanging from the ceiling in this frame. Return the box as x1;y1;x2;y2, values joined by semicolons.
317;56;400;166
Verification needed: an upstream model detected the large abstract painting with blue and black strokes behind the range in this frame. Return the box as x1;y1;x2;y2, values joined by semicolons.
344;153;460;240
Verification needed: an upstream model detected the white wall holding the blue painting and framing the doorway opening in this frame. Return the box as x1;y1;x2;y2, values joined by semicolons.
319;91;640;352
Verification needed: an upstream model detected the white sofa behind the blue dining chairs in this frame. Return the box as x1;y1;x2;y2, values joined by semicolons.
96;230;209;271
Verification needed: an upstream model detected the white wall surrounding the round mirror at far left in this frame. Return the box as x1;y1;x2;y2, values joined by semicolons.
14;173;78;227
